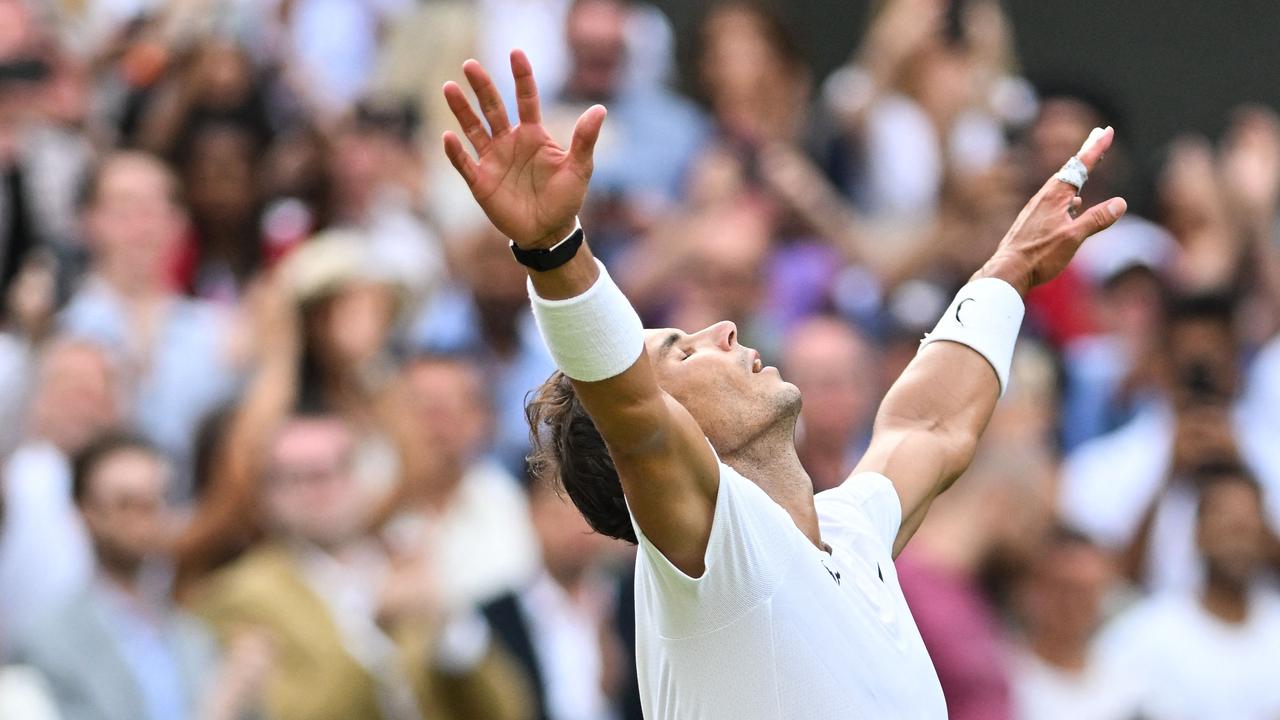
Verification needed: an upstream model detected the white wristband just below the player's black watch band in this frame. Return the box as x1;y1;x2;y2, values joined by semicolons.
529;260;644;382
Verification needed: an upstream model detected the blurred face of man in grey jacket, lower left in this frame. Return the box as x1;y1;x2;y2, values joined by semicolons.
81;448;172;570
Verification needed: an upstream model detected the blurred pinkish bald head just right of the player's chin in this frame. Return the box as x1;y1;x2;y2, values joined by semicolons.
783;318;878;446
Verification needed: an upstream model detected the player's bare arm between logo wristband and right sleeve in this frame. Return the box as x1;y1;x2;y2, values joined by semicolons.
854;342;1000;555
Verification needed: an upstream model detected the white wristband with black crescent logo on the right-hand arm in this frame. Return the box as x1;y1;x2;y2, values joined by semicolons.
920;278;1025;397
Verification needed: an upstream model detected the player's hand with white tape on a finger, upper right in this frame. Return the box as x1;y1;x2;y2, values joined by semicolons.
975;128;1128;295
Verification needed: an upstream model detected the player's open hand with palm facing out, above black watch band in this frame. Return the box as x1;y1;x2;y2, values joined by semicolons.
444;50;605;250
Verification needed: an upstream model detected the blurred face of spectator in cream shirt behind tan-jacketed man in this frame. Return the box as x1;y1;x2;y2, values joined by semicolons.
406;360;492;462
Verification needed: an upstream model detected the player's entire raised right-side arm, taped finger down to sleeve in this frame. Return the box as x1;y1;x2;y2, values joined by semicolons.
855;128;1126;553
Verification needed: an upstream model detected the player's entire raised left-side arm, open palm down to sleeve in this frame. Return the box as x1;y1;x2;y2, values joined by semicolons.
444;50;719;575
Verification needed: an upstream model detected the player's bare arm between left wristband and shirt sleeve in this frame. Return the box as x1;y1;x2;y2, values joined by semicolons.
573;352;719;575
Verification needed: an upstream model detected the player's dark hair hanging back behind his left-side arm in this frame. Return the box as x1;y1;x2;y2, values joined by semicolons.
525;372;639;544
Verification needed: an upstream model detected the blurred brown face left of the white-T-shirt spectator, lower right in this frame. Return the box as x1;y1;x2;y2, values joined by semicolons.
1023;543;1116;643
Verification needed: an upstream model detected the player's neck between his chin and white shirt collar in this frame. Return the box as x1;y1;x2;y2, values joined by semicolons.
722;420;823;548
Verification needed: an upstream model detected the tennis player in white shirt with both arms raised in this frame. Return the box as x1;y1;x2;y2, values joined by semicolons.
444;50;1126;720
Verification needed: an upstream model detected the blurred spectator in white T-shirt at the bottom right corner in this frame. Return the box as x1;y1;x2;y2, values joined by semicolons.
1101;468;1280;720
